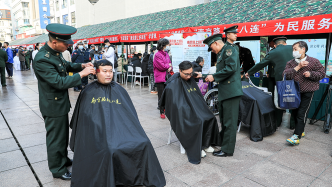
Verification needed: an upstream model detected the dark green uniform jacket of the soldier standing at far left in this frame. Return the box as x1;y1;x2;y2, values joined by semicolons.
32;44;82;117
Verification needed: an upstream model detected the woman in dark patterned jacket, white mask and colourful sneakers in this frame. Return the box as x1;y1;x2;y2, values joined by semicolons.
283;41;325;145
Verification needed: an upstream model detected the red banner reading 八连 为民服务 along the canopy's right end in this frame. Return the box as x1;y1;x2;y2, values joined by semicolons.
189;14;332;37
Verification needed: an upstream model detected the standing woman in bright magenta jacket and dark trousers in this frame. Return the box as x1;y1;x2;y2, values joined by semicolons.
153;38;172;119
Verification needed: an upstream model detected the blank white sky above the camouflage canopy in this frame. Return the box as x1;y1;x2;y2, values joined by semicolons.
75;0;214;27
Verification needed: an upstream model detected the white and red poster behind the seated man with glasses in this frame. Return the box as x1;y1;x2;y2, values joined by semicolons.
183;33;211;74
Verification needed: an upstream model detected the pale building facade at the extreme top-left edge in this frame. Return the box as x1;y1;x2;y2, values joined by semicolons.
0;2;13;43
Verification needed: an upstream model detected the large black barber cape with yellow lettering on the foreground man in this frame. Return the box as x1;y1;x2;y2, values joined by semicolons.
70;81;166;187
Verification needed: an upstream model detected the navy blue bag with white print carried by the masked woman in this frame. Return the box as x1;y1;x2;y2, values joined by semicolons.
274;75;301;109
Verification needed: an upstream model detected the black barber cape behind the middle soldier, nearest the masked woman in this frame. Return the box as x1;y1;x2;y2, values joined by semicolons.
239;81;277;142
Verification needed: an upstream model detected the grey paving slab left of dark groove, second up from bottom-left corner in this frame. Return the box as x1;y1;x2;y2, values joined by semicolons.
0;150;27;172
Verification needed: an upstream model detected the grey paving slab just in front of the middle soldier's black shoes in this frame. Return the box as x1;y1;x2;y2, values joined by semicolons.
204;148;263;173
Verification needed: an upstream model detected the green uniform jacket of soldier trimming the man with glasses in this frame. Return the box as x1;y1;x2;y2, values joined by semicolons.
213;42;243;101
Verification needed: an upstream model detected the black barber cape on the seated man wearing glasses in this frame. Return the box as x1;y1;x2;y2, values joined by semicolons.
159;73;221;164
